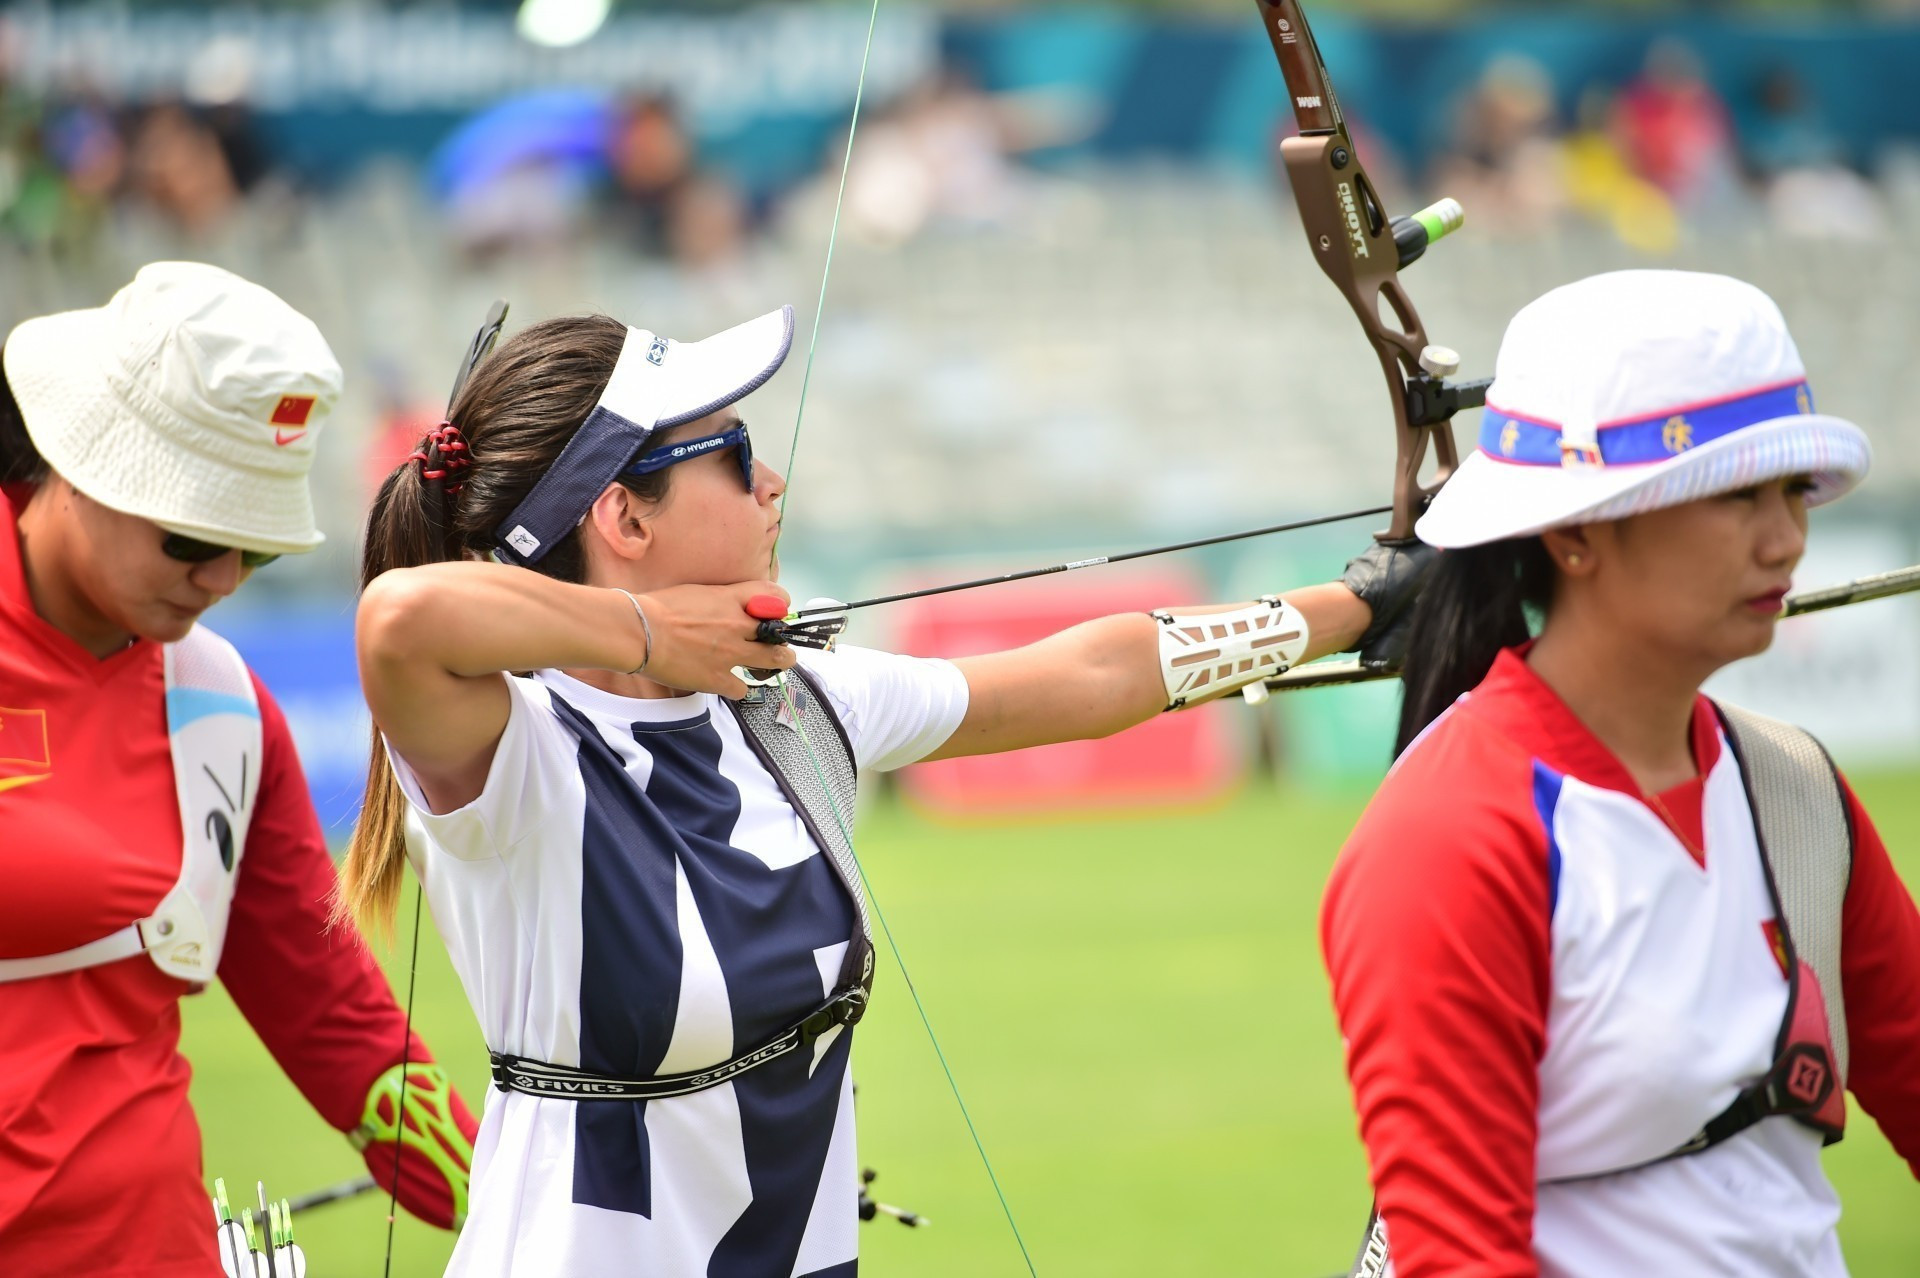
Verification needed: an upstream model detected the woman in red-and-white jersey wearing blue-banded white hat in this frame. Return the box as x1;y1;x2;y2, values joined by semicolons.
1323;271;1920;1278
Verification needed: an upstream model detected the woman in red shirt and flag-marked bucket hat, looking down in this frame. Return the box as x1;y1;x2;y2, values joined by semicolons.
0;263;474;1278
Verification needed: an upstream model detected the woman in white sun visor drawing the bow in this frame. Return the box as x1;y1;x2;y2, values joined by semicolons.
342;307;1443;1278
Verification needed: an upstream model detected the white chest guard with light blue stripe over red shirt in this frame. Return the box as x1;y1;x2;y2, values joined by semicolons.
0;626;261;984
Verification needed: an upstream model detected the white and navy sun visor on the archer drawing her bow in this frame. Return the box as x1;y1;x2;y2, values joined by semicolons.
493;307;793;568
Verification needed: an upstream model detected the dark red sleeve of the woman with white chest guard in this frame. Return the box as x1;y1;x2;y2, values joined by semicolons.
221;677;432;1132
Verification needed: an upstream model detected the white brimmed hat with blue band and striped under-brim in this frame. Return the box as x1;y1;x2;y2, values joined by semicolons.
1415;271;1872;547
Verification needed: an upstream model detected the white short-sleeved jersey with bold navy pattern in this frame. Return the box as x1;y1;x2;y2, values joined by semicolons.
394;649;968;1278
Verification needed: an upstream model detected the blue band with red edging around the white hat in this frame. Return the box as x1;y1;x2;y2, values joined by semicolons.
1480;378;1812;466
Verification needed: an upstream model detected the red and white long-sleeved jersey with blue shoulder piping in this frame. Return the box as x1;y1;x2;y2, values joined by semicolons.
1321;652;1920;1278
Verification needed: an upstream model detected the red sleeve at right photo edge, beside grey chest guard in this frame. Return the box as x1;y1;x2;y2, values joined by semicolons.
1839;771;1920;1178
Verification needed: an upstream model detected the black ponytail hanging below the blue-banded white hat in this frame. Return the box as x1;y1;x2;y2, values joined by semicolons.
1394;537;1553;758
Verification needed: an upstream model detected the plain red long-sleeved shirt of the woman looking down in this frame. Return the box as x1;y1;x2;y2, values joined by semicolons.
0;483;472;1278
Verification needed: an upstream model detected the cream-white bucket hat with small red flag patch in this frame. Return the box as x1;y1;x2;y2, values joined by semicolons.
6;261;342;555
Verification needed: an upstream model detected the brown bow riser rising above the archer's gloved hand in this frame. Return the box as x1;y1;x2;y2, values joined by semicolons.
1254;0;1459;541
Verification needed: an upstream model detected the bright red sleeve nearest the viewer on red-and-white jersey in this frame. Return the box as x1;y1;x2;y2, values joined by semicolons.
1321;725;1551;1278
